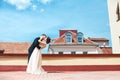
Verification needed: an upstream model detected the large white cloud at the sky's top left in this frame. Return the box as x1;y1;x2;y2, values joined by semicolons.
4;0;31;10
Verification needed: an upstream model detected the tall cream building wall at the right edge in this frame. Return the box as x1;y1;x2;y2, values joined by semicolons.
108;0;120;54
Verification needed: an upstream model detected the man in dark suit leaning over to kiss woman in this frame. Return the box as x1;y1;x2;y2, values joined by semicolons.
28;34;47;62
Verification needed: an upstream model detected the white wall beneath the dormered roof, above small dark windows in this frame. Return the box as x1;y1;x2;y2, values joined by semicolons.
49;46;99;54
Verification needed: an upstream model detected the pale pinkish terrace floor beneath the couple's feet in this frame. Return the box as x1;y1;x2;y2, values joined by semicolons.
0;71;120;80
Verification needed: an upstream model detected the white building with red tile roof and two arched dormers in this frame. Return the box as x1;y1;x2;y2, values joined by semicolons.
48;30;109;54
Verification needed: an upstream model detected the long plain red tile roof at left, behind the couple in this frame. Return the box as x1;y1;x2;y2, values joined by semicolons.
0;42;31;54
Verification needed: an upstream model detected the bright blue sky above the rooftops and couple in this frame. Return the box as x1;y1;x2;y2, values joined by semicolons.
0;0;111;52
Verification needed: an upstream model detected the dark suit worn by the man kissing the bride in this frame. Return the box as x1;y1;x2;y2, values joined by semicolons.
28;37;40;62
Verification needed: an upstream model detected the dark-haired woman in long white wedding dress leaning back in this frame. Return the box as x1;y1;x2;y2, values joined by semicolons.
26;37;50;74
